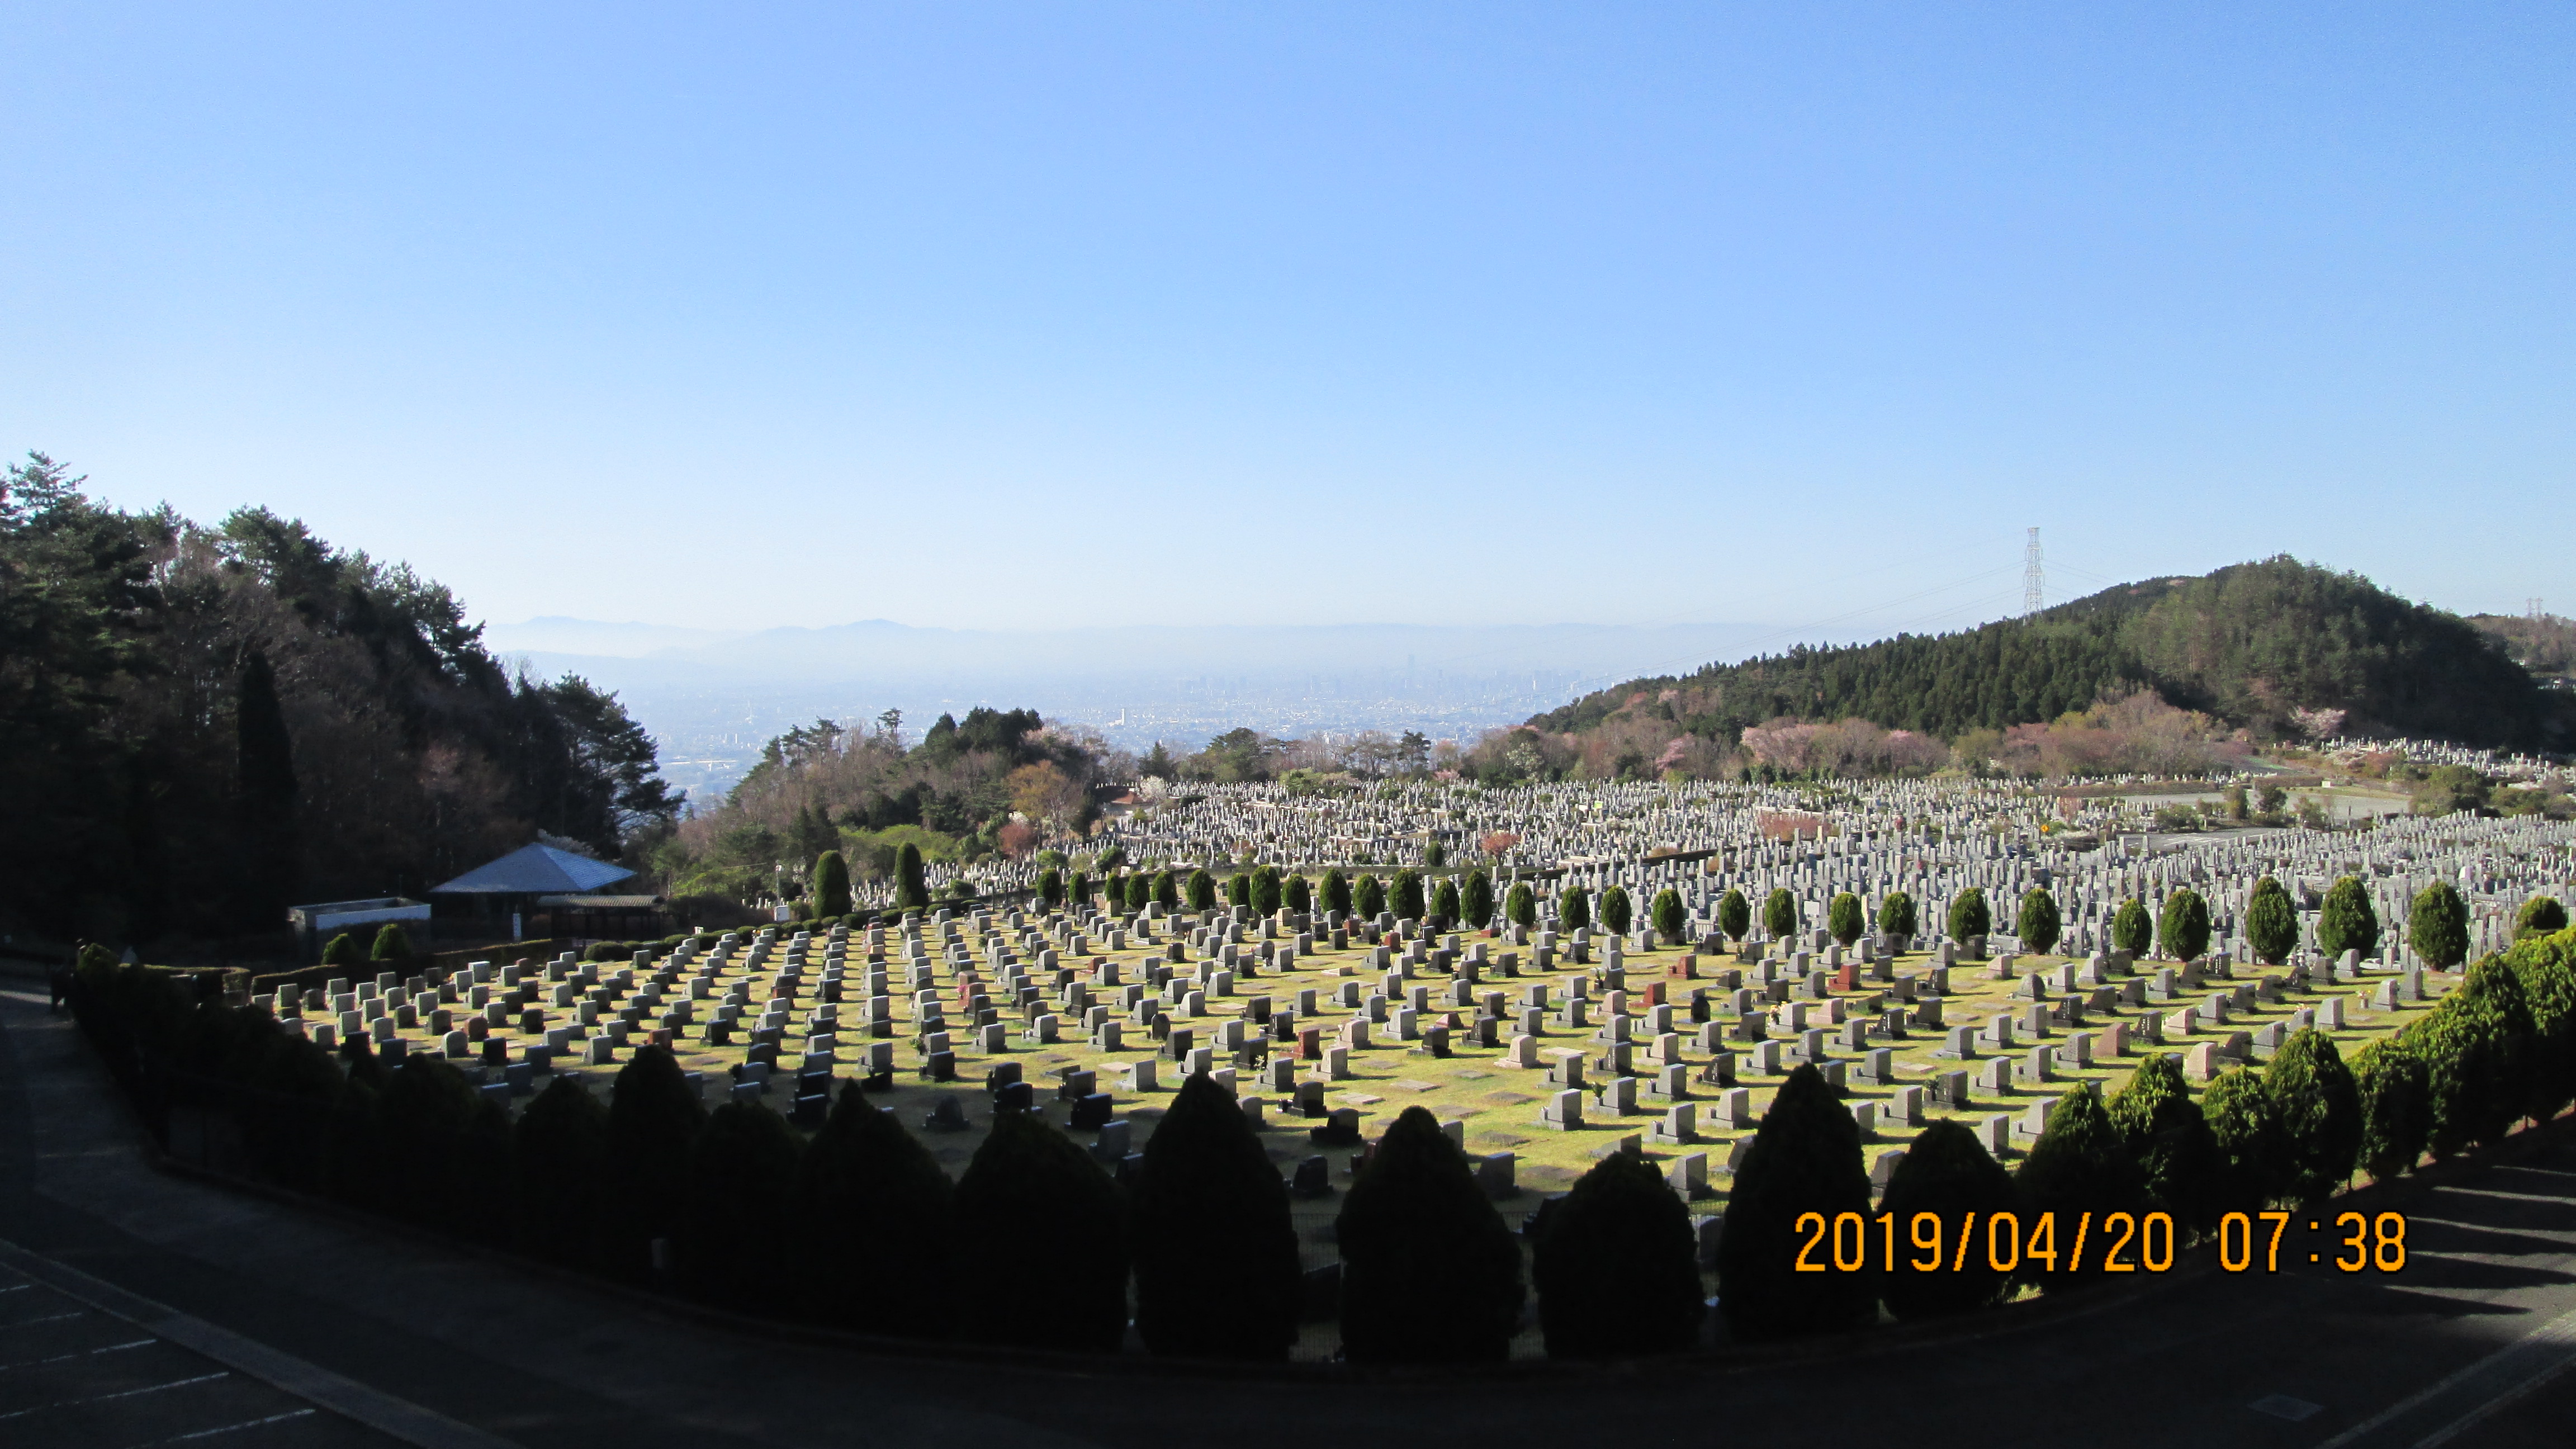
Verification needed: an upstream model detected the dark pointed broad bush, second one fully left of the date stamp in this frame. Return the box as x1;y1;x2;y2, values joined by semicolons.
1334;1106;1525;1364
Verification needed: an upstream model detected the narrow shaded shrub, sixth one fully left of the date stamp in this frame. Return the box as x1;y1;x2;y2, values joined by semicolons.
673;1101;804;1315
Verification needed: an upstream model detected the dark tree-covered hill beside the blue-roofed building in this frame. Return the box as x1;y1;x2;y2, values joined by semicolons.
0;454;678;949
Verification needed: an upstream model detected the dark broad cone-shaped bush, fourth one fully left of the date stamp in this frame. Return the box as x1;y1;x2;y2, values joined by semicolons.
948;1111;1128;1353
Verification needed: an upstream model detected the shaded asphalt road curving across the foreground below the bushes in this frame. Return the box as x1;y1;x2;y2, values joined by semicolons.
15;982;2576;1449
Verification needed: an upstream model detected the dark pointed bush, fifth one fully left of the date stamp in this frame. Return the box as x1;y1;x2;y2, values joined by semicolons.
791;1083;956;1338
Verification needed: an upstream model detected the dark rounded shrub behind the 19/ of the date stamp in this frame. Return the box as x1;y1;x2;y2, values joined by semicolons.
1878;1116;2022;1320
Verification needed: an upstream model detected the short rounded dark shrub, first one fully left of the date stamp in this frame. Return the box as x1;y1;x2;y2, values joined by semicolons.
1530;1153;1708;1359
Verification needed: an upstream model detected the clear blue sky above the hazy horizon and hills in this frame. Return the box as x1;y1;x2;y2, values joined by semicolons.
0;0;2576;634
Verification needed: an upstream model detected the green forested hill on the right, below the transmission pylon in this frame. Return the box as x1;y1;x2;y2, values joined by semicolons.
1530;557;2568;748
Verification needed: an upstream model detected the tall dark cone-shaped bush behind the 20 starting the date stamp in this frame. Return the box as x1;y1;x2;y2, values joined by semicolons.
1718;1065;1878;1338
